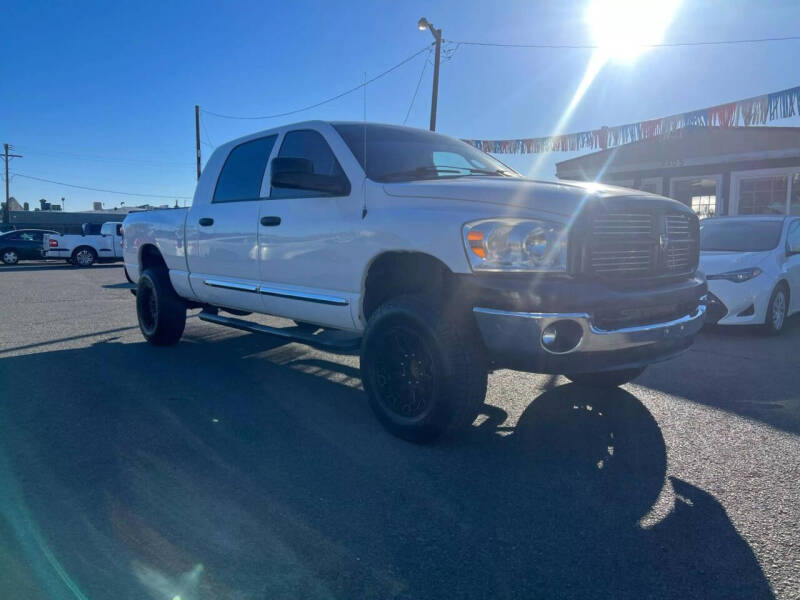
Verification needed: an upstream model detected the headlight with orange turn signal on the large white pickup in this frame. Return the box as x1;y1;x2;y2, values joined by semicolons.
464;218;567;272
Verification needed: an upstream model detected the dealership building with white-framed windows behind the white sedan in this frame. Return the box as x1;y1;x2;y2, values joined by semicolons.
556;127;800;216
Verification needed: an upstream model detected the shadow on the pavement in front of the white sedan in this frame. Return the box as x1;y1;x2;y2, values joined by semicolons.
635;315;800;434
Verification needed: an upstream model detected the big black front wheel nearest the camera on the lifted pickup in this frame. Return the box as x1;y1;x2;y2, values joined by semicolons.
361;295;487;443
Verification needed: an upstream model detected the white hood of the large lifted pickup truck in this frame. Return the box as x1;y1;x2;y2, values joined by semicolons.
383;177;657;216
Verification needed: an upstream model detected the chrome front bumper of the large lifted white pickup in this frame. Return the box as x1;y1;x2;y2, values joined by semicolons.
473;303;706;373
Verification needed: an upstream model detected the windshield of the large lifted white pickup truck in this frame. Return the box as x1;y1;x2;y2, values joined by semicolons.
333;123;519;182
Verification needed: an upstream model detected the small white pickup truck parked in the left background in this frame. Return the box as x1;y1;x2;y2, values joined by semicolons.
42;221;122;267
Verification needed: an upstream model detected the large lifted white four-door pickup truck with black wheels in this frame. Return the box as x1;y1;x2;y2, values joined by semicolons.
124;121;706;441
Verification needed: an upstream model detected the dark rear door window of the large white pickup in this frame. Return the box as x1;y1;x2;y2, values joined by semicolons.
212;135;278;202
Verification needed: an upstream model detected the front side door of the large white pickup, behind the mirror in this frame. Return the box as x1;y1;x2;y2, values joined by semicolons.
258;128;363;328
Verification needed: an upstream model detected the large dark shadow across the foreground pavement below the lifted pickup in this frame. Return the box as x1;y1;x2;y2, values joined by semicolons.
0;335;772;600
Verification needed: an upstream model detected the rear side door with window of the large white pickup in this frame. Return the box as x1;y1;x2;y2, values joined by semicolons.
186;135;277;311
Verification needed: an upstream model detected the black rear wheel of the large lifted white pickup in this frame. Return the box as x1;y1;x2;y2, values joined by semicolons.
136;267;186;346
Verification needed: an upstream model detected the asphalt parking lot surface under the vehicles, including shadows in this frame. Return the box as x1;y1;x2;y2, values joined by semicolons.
0;263;800;600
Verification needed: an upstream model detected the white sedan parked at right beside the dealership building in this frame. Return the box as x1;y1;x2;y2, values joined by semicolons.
700;216;800;334
